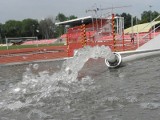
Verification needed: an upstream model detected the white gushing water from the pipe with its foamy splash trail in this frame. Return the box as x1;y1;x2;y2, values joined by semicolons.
4;46;111;110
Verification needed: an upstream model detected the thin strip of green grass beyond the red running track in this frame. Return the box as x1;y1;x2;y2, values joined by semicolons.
0;43;64;50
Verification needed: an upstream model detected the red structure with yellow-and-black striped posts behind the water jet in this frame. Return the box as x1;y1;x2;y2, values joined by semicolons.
63;14;136;57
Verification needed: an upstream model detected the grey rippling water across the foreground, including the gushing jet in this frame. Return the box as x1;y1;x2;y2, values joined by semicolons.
0;47;160;120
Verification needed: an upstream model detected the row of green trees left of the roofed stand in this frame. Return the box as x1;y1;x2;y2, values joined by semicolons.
0;13;77;39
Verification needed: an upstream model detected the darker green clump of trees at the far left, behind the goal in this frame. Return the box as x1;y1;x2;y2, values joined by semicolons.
1;19;39;38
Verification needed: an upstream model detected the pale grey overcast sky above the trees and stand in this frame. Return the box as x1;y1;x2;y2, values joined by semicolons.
0;0;160;23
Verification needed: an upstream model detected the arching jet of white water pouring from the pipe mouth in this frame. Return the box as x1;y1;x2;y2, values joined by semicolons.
61;46;111;81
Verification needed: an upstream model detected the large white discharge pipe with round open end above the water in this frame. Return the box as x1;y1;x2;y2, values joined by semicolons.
105;49;160;68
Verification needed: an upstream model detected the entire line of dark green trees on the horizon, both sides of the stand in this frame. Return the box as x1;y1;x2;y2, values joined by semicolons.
0;11;160;41
